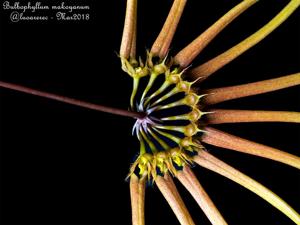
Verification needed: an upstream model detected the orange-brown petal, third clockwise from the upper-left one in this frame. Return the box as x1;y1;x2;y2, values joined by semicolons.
174;0;257;68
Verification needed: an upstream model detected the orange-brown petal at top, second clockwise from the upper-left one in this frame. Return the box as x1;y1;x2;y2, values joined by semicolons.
151;0;187;59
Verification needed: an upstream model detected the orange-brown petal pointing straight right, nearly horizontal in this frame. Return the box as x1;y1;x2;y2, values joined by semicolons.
206;109;300;124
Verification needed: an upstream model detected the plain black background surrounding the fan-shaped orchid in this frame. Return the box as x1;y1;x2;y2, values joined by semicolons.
0;0;300;225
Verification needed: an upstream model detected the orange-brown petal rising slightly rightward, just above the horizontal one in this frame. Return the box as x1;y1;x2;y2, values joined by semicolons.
204;73;300;105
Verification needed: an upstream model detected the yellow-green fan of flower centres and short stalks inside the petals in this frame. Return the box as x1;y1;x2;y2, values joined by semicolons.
121;53;204;178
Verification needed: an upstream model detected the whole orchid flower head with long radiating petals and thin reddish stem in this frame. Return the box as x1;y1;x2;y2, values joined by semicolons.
0;0;300;225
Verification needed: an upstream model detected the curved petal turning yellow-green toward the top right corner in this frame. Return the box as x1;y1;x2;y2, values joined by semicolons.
190;0;300;80
